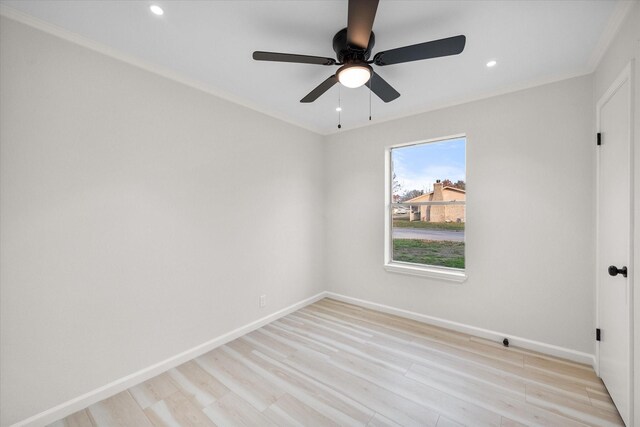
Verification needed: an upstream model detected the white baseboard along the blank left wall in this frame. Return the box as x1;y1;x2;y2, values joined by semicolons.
11;291;326;427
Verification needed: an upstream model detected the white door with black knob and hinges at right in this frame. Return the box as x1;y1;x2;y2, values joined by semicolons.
596;67;632;425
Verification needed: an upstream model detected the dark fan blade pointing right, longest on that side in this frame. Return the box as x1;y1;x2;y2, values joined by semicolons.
373;36;467;65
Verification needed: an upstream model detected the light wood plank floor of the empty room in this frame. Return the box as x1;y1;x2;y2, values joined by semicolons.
53;299;623;427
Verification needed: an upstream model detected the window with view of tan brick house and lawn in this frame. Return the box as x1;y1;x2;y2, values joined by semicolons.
385;136;466;281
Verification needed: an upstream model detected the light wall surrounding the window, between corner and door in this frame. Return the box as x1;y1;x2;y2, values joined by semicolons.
325;76;595;354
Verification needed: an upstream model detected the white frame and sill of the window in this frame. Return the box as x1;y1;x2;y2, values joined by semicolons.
384;134;467;283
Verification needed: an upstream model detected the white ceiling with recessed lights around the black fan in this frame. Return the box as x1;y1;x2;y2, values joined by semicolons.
1;0;620;133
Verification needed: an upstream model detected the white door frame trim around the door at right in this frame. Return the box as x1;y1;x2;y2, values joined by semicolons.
594;60;636;422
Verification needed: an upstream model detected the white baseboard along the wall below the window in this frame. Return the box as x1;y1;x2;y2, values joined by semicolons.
326;292;595;367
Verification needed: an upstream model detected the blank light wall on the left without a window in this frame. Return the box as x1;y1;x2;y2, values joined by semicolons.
0;18;323;426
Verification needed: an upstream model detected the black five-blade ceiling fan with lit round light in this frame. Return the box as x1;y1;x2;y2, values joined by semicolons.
253;0;466;103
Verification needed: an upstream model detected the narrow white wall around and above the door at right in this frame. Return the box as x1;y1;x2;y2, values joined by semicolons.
594;2;640;425
